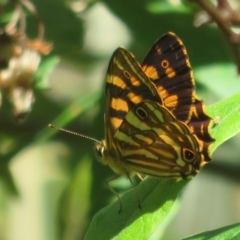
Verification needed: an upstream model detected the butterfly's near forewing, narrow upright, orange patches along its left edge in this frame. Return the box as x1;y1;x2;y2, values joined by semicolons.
105;48;162;153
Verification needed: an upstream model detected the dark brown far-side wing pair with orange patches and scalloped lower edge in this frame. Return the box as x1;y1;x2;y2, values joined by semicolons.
142;32;214;161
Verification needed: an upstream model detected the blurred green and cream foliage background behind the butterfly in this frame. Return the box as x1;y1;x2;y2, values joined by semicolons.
0;0;240;240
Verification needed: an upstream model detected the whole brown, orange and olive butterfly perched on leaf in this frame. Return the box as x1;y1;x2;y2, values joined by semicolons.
95;32;214;211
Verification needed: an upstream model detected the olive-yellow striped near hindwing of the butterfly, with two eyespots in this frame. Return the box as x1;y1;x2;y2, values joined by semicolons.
114;101;204;178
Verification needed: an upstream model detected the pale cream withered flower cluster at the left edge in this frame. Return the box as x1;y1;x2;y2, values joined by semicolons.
0;49;41;119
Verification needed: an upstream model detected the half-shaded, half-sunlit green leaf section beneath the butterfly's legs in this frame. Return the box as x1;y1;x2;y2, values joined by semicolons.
85;177;188;240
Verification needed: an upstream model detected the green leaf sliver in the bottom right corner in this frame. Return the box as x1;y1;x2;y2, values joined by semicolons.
182;223;240;240
